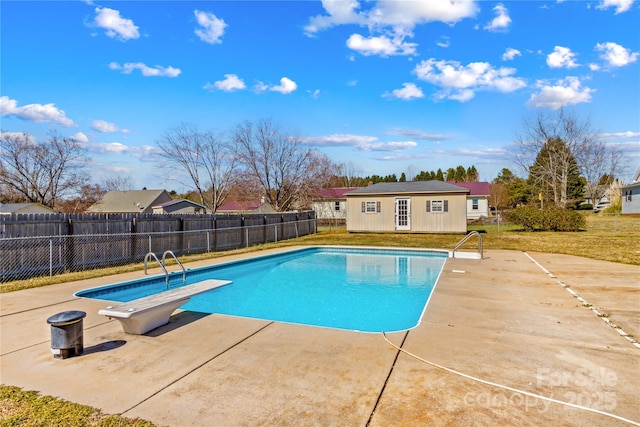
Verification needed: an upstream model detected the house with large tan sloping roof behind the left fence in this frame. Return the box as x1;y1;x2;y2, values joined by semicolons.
87;190;173;214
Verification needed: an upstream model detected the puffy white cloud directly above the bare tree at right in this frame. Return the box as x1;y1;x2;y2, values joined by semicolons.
528;76;595;110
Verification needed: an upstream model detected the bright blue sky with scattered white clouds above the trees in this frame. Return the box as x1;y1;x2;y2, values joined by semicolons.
0;0;640;191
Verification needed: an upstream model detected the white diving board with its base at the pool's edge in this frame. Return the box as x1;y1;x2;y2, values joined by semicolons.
98;279;231;335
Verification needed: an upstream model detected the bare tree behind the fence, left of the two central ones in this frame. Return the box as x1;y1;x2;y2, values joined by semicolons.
158;124;237;212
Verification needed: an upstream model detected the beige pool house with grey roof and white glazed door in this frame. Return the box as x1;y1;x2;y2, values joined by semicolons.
345;180;469;233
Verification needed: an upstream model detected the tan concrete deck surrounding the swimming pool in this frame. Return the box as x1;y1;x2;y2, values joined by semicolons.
0;250;640;426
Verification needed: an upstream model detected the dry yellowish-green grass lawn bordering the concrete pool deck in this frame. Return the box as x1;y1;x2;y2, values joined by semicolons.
0;213;640;427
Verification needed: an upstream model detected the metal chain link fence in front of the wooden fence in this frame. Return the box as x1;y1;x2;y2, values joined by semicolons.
0;218;317;282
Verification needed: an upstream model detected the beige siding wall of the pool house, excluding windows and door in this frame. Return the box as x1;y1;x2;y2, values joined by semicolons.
347;193;467;233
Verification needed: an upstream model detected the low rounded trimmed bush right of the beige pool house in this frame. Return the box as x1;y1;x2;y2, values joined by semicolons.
509;207;586;231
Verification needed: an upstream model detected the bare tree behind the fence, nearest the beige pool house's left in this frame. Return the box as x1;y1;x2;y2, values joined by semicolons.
233;120;335;212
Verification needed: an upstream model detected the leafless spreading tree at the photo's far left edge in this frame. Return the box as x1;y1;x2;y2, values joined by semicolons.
0;132;88;208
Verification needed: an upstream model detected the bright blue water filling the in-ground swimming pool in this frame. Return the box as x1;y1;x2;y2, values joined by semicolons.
76;247;447;332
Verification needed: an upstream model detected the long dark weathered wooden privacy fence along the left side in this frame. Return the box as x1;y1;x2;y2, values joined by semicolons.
0;211;317;282
